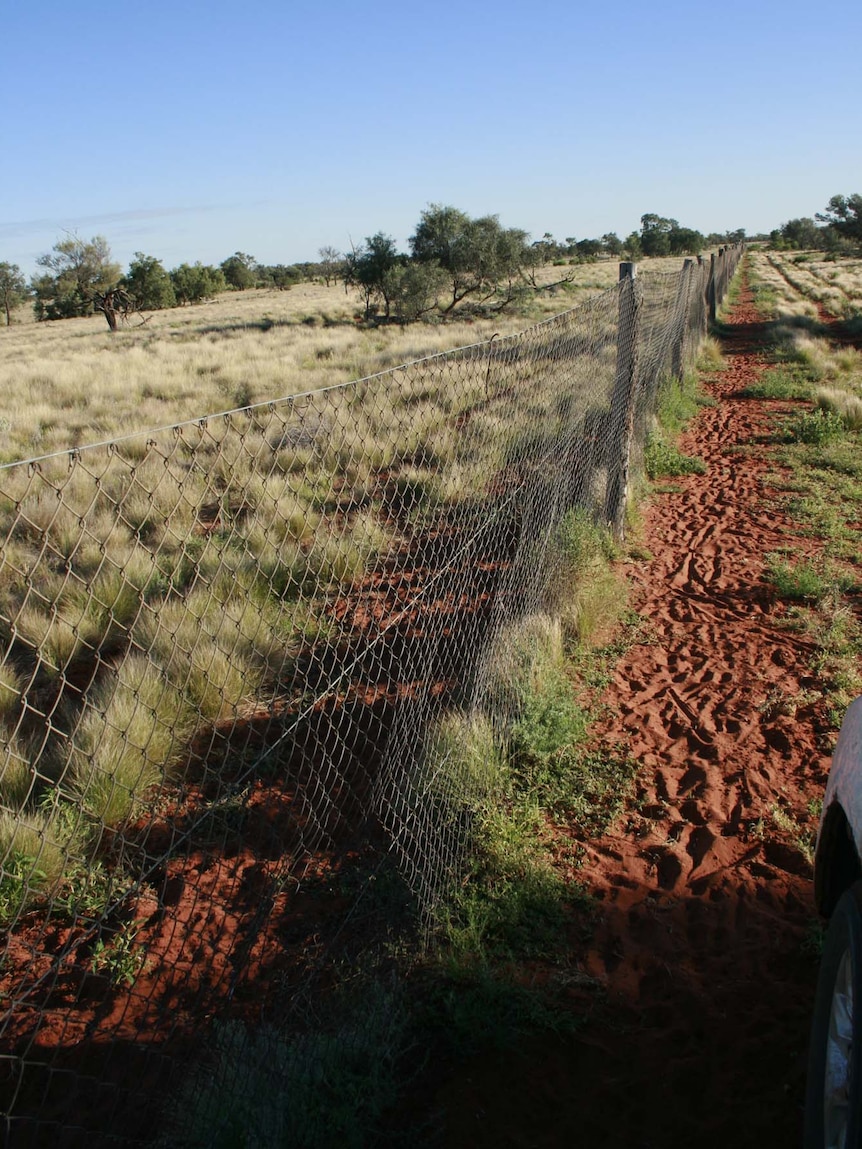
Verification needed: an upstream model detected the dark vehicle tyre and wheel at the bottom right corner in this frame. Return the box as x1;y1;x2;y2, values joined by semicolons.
805;881;862;1149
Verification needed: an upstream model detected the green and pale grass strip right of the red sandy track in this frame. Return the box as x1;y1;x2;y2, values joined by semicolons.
751;253;862;725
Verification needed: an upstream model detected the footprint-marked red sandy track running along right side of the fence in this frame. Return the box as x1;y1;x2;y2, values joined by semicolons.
436;273;850;1149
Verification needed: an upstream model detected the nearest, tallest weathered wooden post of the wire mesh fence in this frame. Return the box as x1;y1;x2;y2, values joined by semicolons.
605;263;640;541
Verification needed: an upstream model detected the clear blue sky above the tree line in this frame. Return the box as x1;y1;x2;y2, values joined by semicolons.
0;0;862;275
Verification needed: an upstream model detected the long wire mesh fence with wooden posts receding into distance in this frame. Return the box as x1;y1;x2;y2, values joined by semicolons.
0;248;740;1146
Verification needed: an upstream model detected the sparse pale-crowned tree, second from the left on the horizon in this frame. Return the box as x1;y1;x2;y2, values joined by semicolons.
32;236;120;319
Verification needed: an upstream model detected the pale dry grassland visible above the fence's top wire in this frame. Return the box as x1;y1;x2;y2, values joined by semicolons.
0;259;680;462
